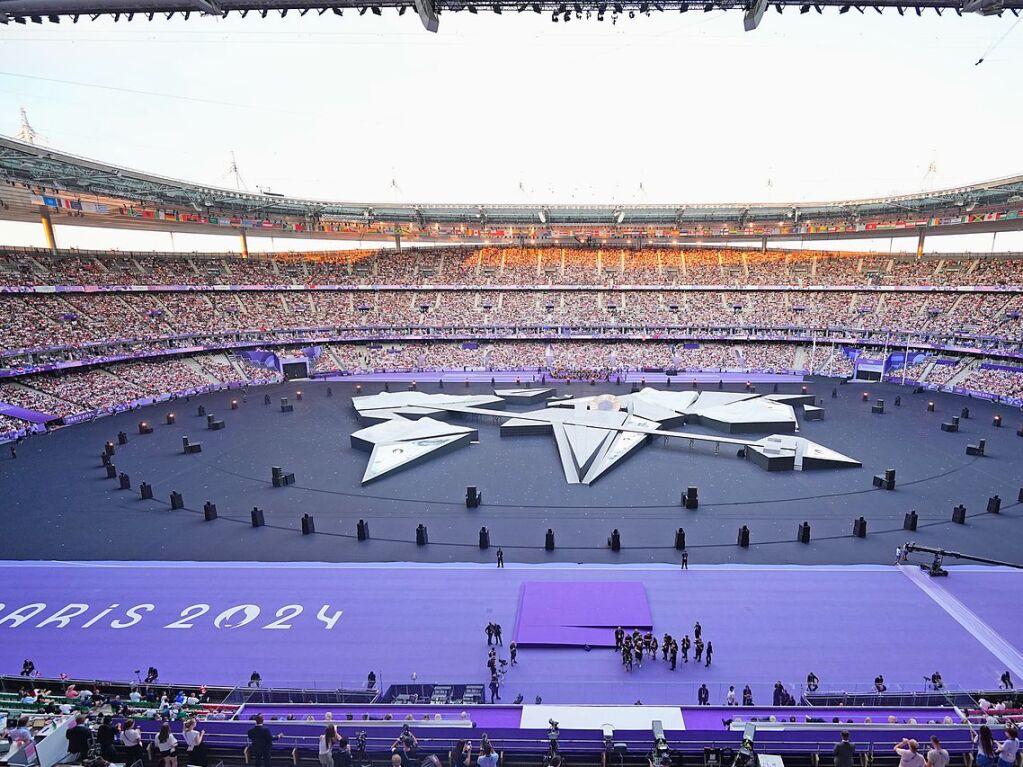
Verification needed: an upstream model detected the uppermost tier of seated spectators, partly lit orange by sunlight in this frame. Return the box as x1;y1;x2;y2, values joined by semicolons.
0;249;1023;287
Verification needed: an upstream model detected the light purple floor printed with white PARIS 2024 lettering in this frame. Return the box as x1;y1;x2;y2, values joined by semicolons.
0;562;1023;706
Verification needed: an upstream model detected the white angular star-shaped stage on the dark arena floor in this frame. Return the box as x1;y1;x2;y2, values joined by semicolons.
352;389;861;485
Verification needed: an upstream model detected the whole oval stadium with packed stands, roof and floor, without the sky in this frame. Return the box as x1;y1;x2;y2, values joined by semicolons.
0;13;1023;767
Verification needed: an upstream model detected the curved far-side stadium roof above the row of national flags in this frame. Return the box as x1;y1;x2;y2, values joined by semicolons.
0;136;1023;237
